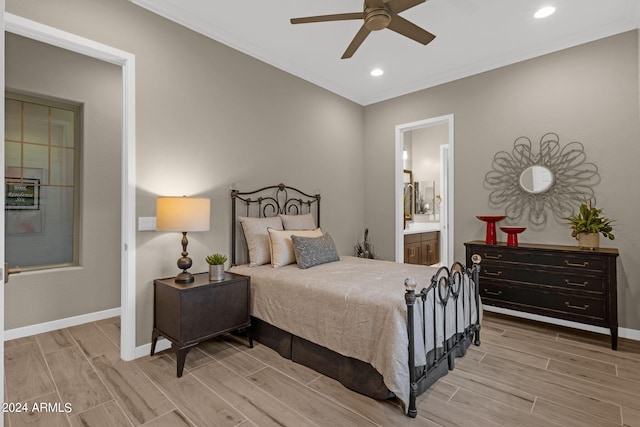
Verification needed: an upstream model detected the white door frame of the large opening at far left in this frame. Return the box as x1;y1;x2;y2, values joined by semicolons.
1;12;136;362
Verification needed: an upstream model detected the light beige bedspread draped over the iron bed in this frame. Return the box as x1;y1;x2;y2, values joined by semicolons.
231;257;476;408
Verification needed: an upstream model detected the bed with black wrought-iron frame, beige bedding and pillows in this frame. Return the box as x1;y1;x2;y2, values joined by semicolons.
231;184;480;417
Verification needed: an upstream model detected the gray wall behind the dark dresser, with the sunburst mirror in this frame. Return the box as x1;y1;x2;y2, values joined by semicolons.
364;31;640;330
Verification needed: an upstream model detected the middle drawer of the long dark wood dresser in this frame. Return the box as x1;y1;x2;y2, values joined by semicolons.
480;262;607;295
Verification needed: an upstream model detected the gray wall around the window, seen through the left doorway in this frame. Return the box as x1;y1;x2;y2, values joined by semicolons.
5;34;122;329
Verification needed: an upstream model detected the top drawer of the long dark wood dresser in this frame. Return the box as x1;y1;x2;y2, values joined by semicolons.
473;246;606;271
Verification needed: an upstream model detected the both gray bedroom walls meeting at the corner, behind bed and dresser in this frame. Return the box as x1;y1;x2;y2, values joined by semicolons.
6;0;640;345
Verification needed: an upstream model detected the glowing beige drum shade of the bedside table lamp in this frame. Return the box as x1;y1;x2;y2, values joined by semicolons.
156;197;211;232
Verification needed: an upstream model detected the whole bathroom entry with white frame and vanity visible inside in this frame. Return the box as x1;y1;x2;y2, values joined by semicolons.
396;115;453;265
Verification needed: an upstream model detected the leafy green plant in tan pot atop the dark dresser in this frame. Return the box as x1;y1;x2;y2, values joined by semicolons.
566;201;615;249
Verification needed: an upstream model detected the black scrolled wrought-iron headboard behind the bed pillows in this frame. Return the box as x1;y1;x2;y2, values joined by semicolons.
231;184;320;266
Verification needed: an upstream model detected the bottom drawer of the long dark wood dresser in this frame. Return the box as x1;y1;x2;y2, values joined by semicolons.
480;281;607;321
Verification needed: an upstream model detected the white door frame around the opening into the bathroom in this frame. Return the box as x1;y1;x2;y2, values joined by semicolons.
395;114;454;265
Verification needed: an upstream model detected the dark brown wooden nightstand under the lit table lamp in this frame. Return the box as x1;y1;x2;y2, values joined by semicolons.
151;272;253;377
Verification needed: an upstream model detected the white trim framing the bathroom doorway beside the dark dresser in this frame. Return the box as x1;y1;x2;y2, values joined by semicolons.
395;114;454;265
